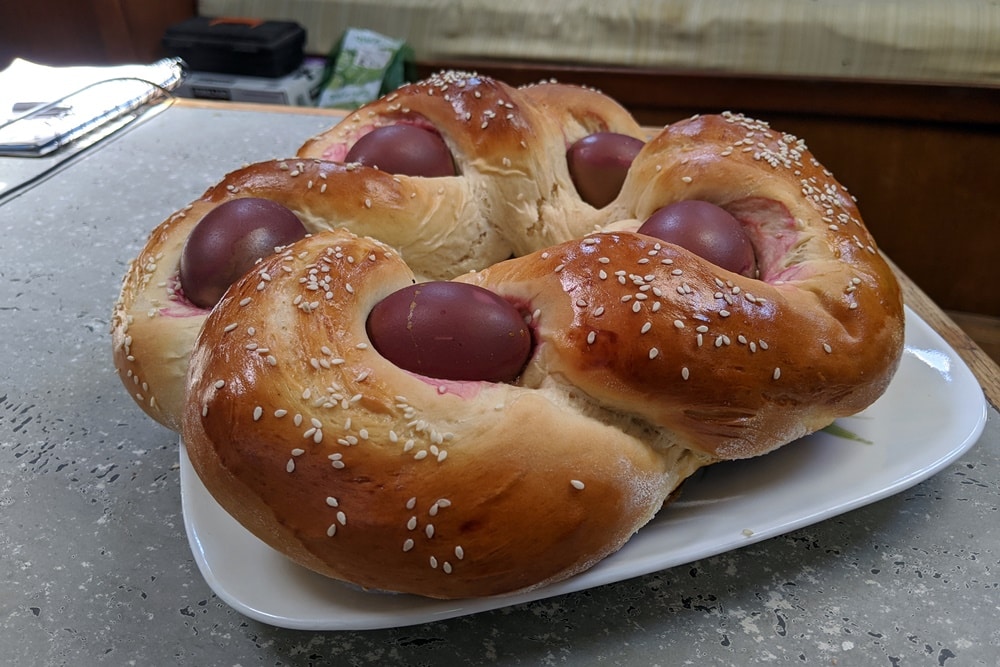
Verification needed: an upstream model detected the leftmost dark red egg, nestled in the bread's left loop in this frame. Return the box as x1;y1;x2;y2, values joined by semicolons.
180;197;306;308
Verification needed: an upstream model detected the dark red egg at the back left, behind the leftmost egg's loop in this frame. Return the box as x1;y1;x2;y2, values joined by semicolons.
345;124;456;177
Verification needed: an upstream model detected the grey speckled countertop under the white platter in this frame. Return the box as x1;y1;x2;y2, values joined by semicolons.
0;105;1000;667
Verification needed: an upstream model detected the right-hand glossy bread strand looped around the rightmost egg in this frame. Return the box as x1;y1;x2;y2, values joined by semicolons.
460;115;903;459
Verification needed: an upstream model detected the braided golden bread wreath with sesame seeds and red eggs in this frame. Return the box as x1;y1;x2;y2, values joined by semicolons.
112;72;903;598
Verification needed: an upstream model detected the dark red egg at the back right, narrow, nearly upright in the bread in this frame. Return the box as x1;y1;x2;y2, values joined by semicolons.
566;132;644;208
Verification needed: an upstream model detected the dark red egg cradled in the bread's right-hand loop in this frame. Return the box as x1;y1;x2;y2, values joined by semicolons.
638;200;757;278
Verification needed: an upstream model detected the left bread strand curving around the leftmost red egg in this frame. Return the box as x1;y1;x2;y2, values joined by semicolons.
112;159;510;430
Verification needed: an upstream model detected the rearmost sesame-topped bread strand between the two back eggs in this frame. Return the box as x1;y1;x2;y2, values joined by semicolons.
299;72;647;253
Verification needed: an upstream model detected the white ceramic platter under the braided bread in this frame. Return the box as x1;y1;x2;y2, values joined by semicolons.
180;309;986;630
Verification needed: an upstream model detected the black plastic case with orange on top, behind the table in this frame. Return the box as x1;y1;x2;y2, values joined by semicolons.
163;16;306;77
